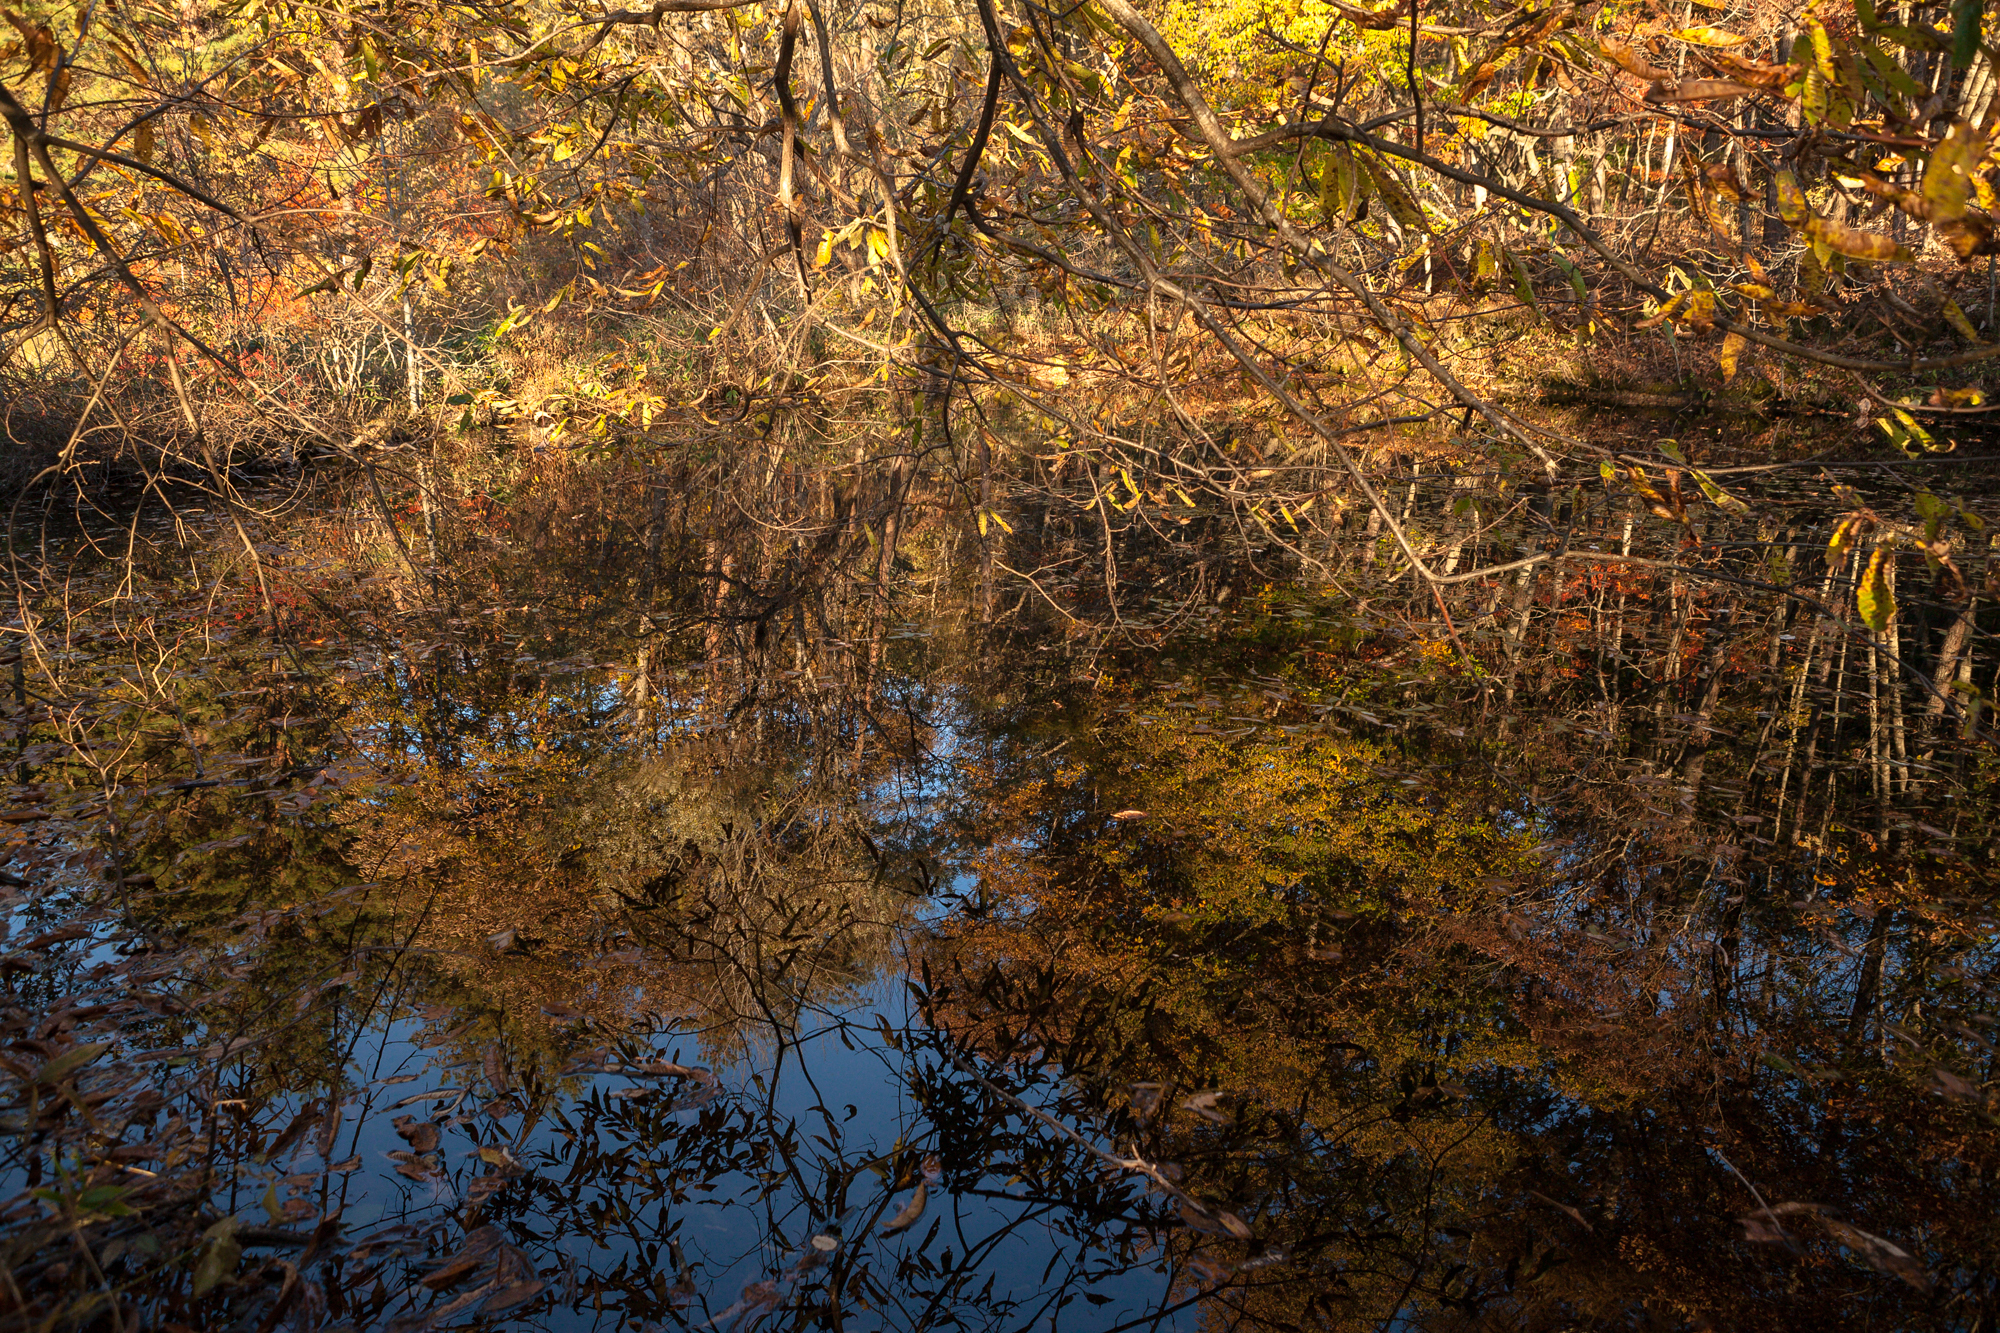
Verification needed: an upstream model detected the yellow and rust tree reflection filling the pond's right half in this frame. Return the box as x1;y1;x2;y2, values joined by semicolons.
924;676;2000;1329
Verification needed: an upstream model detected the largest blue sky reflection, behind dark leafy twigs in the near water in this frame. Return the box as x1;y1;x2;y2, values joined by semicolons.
238;960;1176;1329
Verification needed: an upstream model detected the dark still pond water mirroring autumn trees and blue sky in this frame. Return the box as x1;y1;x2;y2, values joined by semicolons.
0;464;2000;1331
